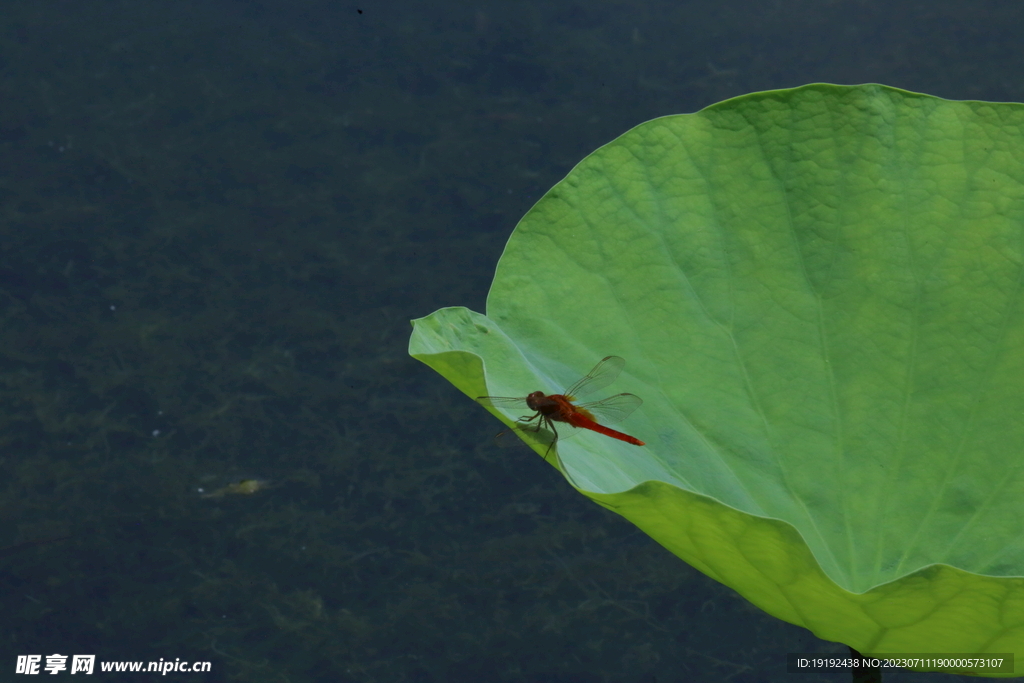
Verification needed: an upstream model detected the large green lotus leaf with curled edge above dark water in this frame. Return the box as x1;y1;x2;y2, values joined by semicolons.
410;84;1024;676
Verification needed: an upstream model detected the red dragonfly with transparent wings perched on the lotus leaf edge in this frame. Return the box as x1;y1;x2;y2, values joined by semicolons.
476;355;644;462
